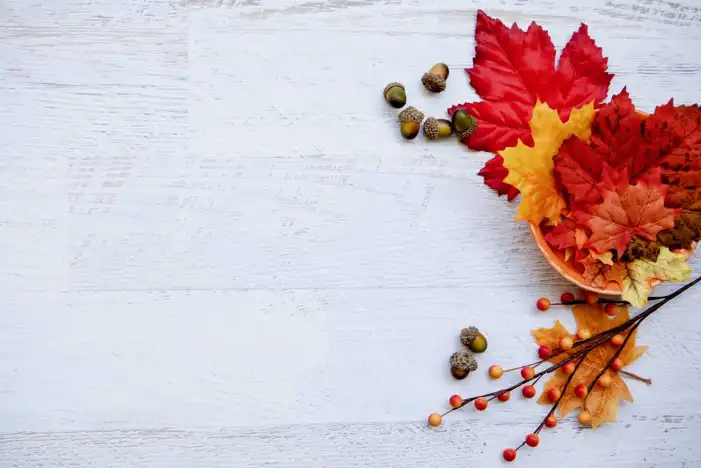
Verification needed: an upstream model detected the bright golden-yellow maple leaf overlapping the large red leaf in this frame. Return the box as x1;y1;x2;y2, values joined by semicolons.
499;101;594;224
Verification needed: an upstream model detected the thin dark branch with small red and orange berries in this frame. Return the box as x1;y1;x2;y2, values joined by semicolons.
428;277;701;462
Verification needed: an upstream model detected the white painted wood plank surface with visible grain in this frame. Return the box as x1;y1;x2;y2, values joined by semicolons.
0;0;701;468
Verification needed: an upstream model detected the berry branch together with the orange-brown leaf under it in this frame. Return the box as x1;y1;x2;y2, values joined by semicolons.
428;277;701;461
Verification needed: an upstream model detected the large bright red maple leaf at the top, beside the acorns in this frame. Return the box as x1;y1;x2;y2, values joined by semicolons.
448;10;613;194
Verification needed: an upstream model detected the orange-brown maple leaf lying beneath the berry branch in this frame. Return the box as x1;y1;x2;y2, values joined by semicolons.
531;304;647;428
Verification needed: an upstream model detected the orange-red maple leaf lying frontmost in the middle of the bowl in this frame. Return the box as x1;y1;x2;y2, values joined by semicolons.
572;166;676;257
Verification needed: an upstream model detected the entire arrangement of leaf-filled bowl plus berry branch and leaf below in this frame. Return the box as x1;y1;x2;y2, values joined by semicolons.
428;11;701;461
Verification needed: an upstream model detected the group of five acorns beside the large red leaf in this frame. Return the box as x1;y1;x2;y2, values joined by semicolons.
382;63;477;140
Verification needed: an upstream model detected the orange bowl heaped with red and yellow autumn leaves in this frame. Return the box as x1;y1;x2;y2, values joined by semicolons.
448;11;701;307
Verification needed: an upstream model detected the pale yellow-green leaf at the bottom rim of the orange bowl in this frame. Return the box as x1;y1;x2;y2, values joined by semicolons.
621;247;691;307
